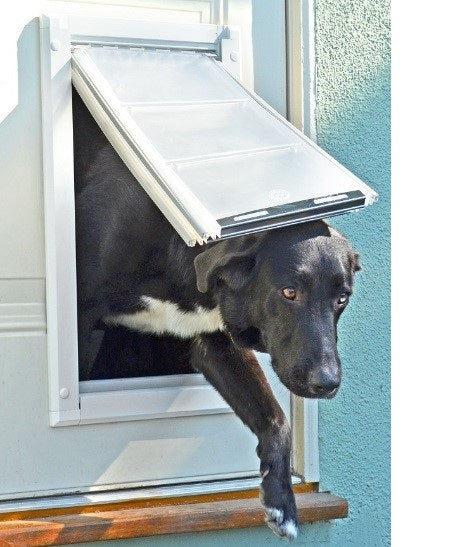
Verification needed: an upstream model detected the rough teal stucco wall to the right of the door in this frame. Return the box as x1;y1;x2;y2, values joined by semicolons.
57;0;390;547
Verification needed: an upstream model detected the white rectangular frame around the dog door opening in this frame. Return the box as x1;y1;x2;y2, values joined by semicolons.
40;16;318;488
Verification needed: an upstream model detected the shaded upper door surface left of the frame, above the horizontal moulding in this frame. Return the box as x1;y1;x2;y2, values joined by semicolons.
0;19;44;279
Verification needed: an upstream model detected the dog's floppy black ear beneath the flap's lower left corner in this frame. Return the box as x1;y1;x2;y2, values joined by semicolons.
194;234;263;293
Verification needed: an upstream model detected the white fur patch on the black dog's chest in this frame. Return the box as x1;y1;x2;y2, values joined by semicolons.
104;296;224;338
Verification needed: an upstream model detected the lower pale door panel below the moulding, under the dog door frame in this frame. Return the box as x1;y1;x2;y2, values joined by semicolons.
0;332;266;499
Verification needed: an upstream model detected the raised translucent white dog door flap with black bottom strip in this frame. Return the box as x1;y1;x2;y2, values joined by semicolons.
72;45;377;245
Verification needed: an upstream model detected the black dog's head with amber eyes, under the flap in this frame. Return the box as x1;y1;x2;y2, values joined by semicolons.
195;221;360;398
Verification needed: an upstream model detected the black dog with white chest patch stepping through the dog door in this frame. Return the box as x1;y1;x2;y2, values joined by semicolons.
74;89;360;539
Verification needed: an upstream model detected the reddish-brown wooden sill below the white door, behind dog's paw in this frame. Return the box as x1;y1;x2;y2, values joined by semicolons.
0;485;348;547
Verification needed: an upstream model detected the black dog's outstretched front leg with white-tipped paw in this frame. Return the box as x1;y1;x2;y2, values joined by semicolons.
191;333;298;540
